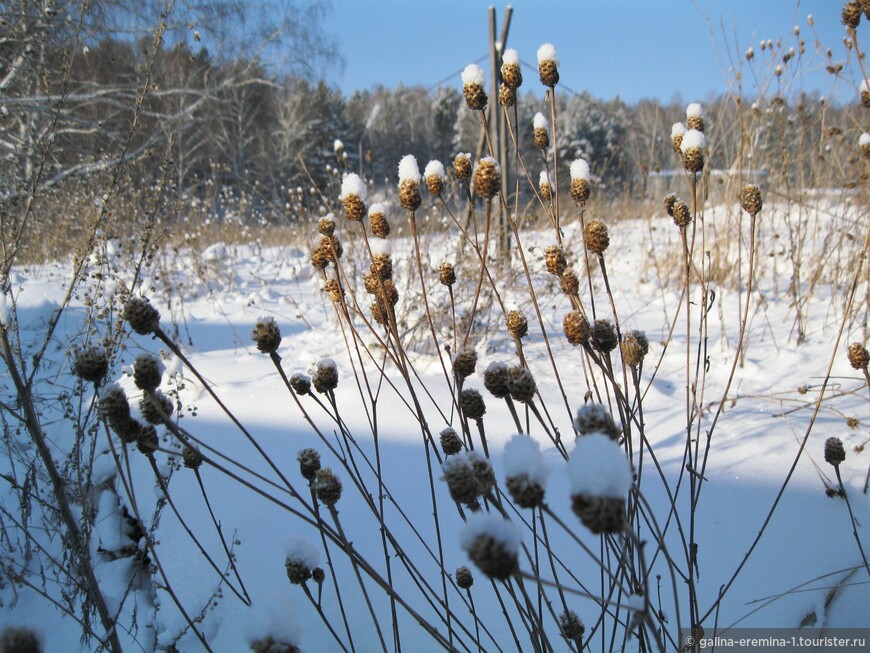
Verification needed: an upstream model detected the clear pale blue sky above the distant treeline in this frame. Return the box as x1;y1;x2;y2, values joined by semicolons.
324;0;870;102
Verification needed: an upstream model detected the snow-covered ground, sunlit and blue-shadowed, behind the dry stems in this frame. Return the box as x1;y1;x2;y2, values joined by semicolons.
0;201;870;651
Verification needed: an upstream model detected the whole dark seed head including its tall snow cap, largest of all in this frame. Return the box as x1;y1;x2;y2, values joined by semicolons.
568;433;632;535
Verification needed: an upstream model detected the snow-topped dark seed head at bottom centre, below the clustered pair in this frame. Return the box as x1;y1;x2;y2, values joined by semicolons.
461;512;522;580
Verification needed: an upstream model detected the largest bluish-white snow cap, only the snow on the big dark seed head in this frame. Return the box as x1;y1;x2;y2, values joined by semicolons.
568;433;631;498
